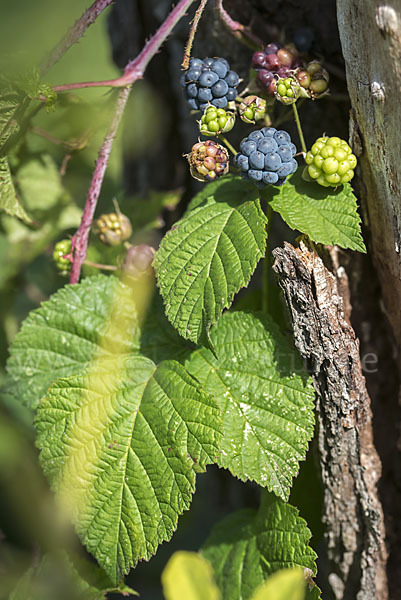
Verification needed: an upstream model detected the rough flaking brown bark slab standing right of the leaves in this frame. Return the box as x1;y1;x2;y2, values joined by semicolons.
273;243;388;600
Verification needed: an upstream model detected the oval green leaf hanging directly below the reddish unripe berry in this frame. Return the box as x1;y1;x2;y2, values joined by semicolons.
154;177;267;342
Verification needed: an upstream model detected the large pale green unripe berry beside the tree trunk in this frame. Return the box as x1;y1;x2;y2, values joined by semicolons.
305;137;357;187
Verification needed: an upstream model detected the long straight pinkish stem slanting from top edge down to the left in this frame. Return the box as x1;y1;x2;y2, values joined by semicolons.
70;0;194;283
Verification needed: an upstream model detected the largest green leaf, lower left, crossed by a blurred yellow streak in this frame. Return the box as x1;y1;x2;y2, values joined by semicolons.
35;356;221;583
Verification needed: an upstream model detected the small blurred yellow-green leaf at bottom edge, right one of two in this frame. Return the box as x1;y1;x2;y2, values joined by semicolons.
252;568;306;600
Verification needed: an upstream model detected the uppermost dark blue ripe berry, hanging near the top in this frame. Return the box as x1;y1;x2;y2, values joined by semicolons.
181;58;239;110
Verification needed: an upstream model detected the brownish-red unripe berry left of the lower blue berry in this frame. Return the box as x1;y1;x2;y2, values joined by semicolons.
186;140;230;181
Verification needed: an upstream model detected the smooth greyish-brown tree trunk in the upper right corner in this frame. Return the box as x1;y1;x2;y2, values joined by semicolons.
337;0;401;349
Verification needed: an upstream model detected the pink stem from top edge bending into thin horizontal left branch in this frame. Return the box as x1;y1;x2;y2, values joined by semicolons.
49;0;195;95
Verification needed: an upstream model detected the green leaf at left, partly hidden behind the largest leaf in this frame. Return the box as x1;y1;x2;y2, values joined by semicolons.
7;275;191;408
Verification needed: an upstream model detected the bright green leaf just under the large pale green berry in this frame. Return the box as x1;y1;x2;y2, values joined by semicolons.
263;169;366;252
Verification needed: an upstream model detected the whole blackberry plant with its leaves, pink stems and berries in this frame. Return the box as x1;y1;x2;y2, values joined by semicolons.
0;0;378;600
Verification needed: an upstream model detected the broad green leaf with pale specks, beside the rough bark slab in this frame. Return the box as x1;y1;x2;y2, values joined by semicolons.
186;312;314;499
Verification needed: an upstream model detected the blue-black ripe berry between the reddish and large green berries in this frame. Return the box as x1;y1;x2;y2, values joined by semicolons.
234;127;298;187
